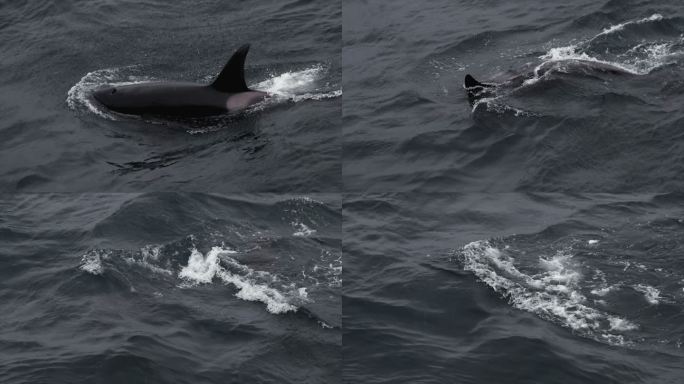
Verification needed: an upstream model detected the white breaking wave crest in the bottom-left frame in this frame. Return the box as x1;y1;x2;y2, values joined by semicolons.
79;236;342;314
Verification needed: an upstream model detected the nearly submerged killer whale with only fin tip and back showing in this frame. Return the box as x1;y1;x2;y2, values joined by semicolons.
463;59;636;105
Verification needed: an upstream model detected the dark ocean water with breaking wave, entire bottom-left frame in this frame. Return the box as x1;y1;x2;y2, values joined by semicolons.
0;193;342;383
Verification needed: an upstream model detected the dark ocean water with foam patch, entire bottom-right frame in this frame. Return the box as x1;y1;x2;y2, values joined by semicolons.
343;193;684;384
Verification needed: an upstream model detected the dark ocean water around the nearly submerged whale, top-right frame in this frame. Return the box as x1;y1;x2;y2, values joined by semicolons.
342;0;684;193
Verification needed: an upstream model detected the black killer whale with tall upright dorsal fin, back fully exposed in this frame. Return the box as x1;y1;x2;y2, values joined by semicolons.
93;44;268;116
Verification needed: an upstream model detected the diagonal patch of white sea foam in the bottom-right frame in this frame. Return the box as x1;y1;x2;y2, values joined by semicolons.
461;241;638;344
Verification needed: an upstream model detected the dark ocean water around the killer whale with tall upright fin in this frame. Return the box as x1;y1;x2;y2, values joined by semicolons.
0;0;342;192
